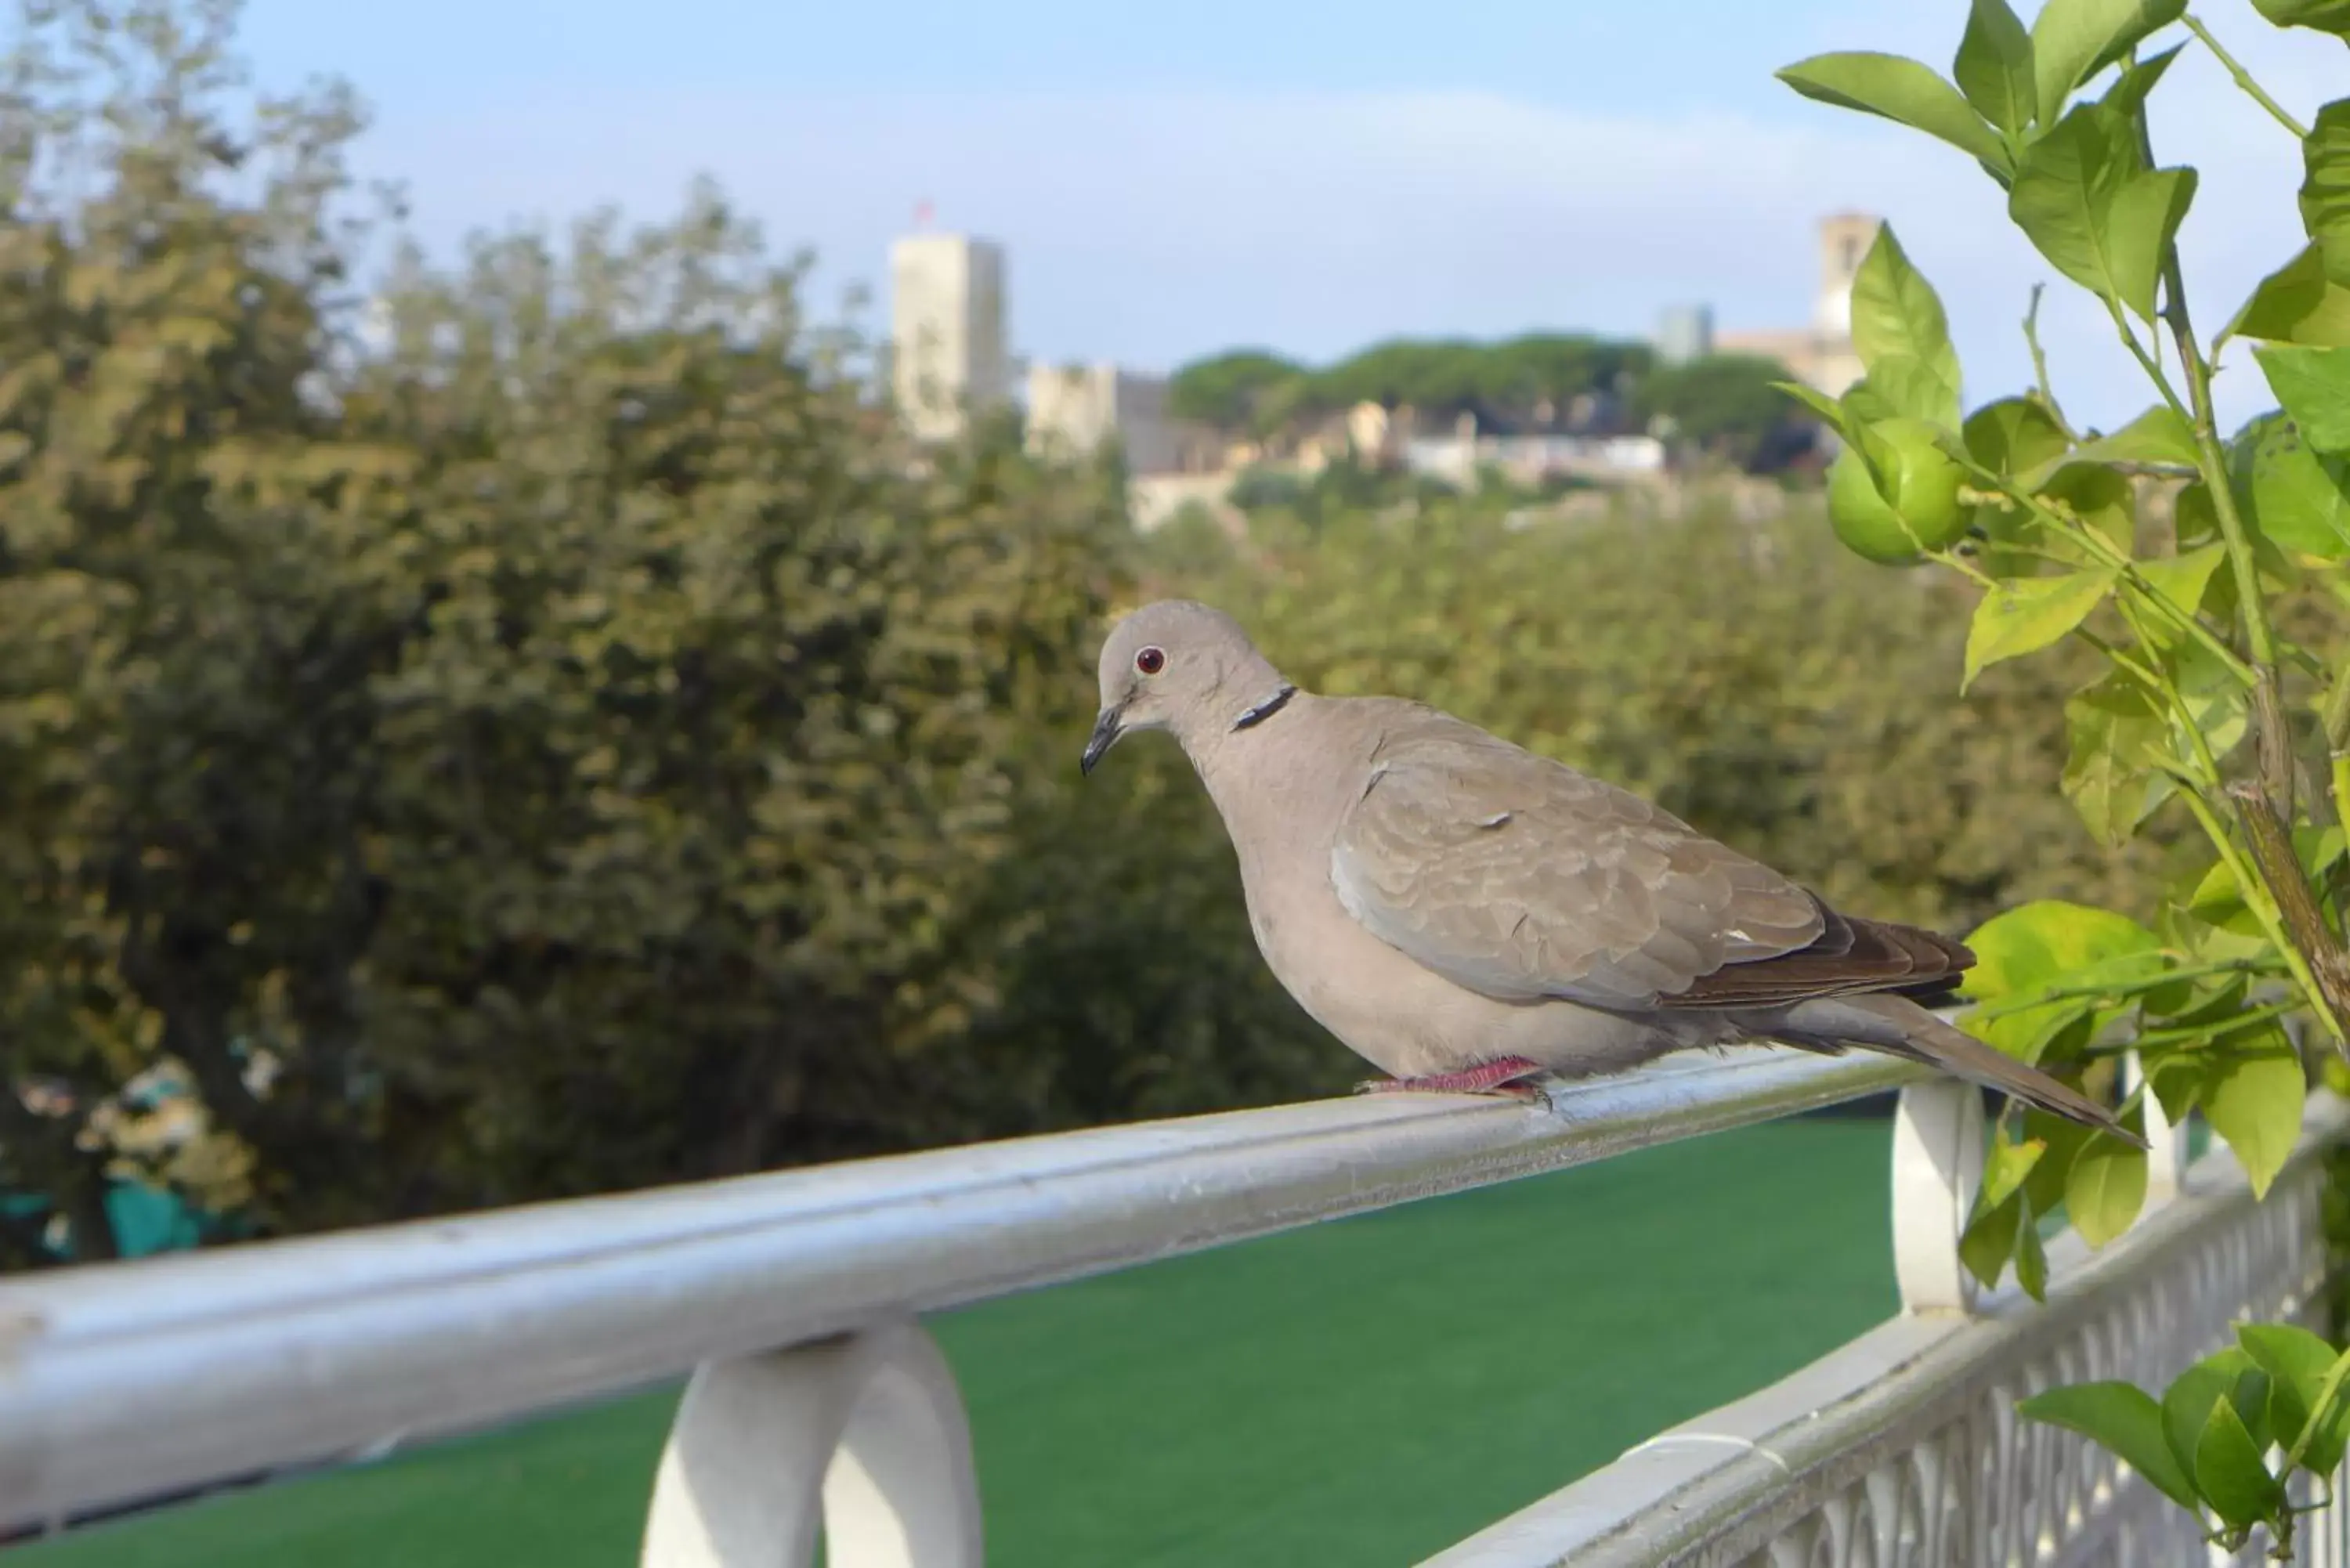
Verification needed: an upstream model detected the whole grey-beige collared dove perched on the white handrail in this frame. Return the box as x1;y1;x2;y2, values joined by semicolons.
1081;599;2141;1143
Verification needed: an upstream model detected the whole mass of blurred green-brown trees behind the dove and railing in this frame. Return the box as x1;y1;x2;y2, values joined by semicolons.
0;0;2160;1263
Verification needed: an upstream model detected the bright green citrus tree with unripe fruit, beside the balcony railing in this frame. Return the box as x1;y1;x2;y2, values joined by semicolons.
1779;0;2350;1561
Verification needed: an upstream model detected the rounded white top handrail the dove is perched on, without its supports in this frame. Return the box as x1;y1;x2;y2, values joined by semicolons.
0;1049;1920;1528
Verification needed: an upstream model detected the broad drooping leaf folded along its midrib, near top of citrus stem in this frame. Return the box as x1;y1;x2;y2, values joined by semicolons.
2007;103;2195;322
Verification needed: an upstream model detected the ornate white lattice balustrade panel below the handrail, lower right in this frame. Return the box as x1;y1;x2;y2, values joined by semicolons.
1426;1096;2350;1568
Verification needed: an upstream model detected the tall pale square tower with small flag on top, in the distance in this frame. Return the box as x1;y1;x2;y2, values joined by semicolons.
888;235;1013;439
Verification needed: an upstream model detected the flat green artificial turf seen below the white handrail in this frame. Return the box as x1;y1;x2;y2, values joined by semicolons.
9;1119;1894;1568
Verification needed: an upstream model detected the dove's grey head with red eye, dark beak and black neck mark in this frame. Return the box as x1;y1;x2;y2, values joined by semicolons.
1079;599;1297;773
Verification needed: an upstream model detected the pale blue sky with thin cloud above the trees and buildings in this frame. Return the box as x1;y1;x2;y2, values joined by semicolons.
244;0;2350;421
